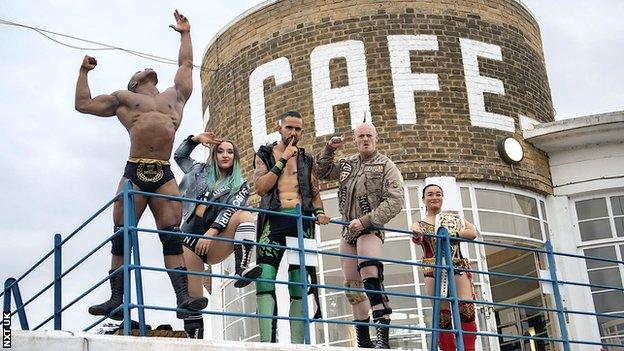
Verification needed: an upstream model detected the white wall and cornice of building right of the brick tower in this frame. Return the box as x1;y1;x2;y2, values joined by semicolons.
524;111;624;351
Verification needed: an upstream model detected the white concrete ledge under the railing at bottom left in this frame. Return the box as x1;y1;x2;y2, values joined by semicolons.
11;330;366;351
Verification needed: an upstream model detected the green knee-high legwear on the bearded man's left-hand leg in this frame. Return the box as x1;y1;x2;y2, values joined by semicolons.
256;263;277;342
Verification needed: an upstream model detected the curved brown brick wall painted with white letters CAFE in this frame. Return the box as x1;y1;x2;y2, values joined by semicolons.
201;0;553;193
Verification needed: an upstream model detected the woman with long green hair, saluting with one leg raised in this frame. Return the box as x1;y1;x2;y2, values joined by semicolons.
174;132;262;339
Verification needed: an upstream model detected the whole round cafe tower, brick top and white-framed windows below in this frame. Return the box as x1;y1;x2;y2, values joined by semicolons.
201;0;554;350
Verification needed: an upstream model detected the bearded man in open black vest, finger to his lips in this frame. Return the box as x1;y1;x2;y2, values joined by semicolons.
254;111;329;344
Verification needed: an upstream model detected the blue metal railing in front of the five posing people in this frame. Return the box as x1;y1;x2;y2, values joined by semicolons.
0;182;624;351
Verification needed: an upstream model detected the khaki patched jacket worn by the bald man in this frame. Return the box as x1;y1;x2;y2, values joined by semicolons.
317;145;403;228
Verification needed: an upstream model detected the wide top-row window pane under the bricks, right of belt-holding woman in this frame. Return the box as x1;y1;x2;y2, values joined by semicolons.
476;189;538;217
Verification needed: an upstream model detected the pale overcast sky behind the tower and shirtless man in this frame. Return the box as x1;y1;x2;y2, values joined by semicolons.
0;0;624;330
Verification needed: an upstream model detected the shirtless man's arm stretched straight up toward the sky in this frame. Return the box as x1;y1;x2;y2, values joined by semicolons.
169;10;193;103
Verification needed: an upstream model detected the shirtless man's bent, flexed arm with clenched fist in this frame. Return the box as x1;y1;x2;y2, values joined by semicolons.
74;55;119;117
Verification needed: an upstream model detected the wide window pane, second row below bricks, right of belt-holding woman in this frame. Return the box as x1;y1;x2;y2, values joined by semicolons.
479;211;542;240
